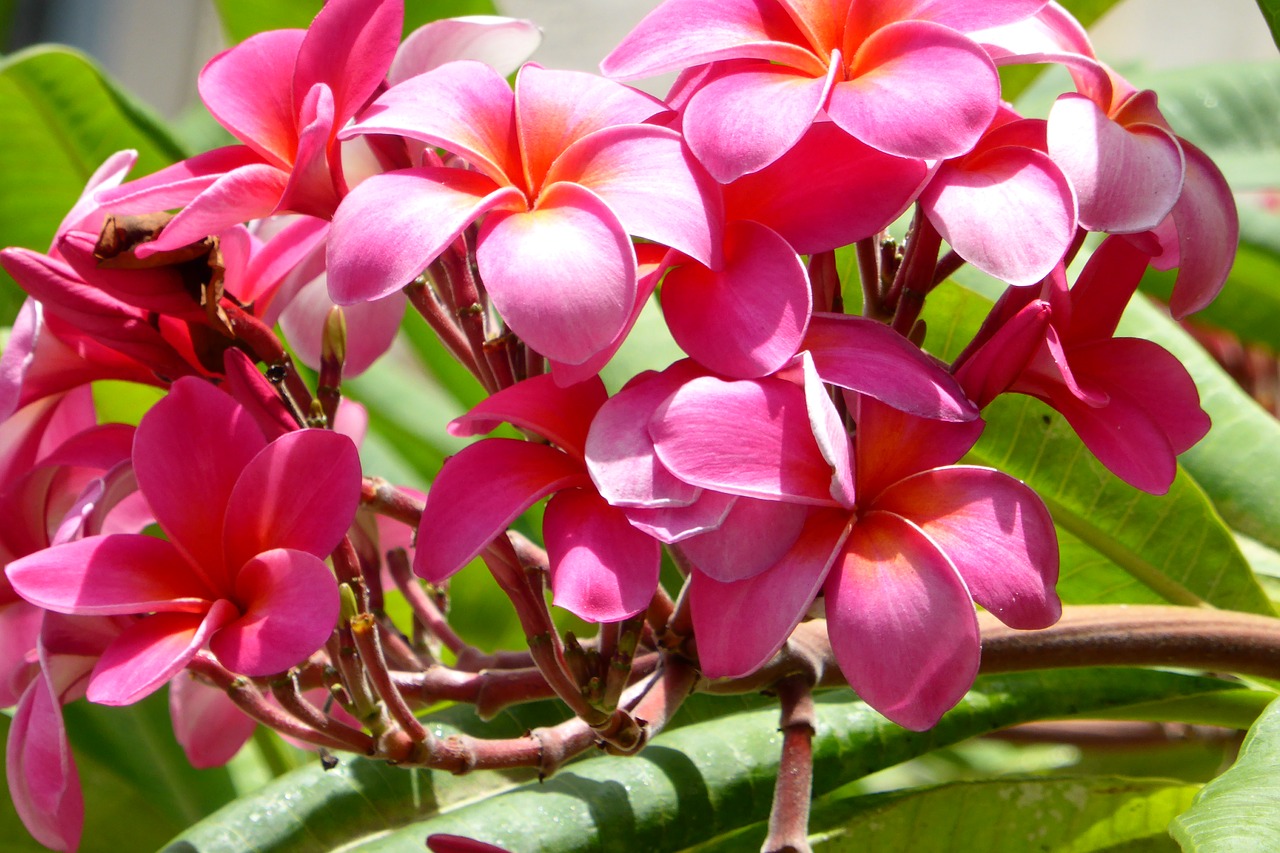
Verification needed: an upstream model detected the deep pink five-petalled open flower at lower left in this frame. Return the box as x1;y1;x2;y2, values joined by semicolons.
6;379;360;704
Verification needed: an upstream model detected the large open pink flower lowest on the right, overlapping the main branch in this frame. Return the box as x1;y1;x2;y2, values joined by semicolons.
650;362;1060;730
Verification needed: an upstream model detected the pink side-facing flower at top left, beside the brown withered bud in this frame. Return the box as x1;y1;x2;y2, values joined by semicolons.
100;0;404;256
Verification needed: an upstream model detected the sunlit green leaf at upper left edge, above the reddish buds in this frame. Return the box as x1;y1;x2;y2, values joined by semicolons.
0;45;187;325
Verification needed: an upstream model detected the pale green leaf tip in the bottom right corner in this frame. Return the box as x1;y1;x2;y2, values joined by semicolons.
1170;699;1280;853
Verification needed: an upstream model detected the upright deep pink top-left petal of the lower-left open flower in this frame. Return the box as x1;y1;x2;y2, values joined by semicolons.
133;378;266;573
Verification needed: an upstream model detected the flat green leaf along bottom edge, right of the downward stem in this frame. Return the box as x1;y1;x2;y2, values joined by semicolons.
696;776;1199;853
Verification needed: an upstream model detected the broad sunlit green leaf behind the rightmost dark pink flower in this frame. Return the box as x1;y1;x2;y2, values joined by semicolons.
925;284;1272;613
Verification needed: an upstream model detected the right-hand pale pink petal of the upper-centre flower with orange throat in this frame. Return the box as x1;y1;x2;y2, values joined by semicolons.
547;124;722;265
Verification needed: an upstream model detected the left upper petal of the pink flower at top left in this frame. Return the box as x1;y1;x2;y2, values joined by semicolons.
198;29;306;167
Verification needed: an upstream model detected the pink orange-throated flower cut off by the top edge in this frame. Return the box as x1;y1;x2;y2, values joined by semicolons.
600;0;1044;183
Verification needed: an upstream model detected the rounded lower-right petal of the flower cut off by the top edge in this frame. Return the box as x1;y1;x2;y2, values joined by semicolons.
827;20;1000;160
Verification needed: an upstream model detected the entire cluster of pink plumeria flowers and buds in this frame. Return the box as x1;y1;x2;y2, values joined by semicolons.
0;0;1236;848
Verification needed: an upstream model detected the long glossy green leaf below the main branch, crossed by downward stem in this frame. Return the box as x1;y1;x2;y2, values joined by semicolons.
165;670;1230;853
